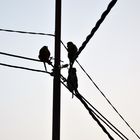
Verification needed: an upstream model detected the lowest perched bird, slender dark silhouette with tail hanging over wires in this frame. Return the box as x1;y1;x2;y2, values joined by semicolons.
67;68;78;98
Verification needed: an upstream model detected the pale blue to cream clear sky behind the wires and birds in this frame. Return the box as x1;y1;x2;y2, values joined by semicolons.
0;0;140;140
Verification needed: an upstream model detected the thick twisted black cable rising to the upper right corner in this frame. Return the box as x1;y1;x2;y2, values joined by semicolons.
75;0;117;58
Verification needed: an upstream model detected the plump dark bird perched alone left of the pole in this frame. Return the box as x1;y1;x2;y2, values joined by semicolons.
38;46;52;71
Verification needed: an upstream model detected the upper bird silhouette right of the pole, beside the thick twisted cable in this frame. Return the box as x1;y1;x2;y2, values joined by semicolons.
67;42;77;67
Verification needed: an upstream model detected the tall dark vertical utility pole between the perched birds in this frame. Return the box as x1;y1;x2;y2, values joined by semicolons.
52;0;61;140
